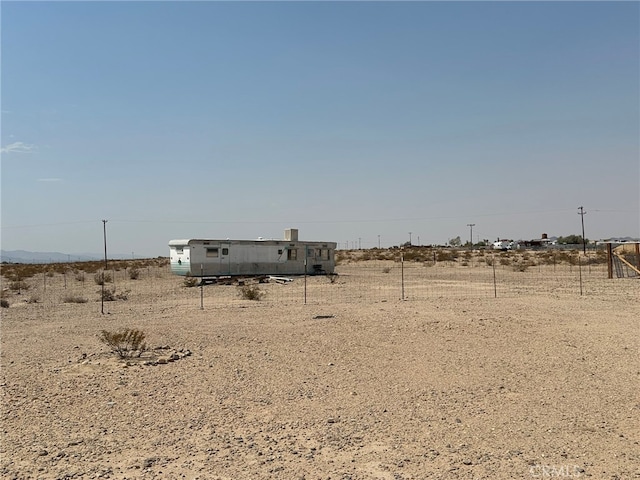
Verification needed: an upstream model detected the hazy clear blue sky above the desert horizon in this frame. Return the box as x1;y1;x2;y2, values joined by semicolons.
1;1;640;256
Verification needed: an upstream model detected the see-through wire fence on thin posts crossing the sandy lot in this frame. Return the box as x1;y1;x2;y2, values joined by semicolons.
3;255;640;314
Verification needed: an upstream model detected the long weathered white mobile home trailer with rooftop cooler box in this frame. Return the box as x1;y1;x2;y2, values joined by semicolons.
169;229;337;277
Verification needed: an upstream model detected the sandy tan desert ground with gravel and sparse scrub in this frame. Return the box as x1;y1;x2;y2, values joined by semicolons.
0;251;640;480
